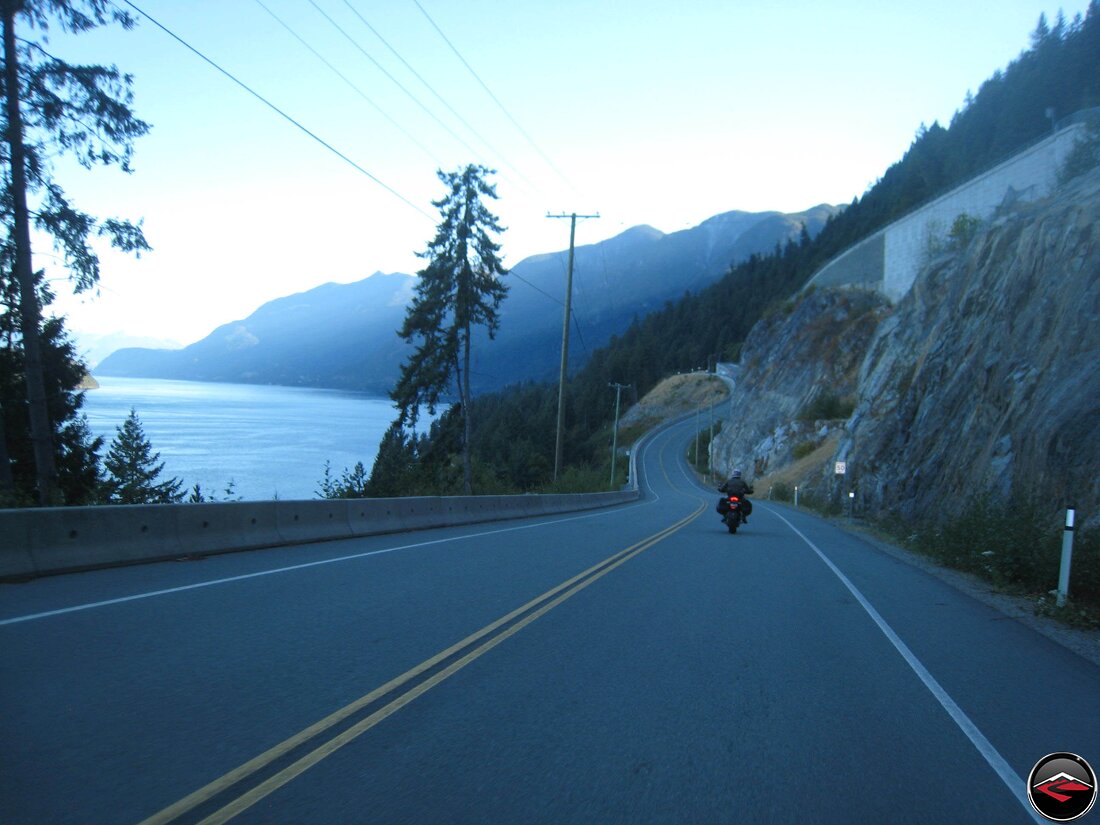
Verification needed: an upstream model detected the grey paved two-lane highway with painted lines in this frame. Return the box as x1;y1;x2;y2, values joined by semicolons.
0;415;1100;825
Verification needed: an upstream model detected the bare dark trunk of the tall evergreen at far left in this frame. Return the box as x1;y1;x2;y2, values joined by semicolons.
3;0;57;506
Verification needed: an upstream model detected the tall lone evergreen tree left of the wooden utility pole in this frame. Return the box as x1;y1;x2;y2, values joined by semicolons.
391;164;507;495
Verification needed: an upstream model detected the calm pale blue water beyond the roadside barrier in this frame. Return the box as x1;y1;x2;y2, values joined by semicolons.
84;377;395;501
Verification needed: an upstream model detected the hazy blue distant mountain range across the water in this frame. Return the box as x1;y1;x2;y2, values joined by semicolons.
101;205;839;394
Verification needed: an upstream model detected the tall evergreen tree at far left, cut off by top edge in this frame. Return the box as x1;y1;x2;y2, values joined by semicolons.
0;0;149;504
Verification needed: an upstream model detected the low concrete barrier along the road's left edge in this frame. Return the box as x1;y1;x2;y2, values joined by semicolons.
0;490;639;581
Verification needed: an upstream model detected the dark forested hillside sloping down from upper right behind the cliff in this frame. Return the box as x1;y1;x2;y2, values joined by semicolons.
369;8;1100;495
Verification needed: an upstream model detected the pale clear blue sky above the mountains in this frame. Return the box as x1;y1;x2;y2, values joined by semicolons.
35;0;1087;352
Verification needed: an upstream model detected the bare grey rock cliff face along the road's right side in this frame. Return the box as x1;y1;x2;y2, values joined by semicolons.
715;171;1100;524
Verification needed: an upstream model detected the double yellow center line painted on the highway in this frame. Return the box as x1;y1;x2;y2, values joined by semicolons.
141;504;705;825
